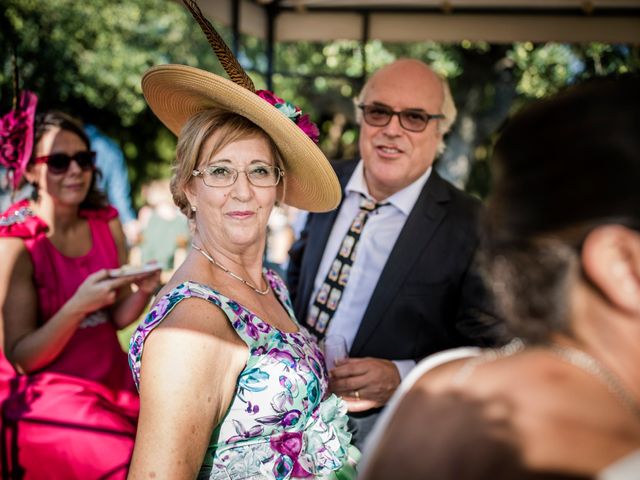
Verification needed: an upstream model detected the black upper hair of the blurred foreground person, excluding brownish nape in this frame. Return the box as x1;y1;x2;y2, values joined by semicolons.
490;77;640;244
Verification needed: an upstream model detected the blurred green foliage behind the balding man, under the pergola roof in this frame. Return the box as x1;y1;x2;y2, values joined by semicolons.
268;41;640;197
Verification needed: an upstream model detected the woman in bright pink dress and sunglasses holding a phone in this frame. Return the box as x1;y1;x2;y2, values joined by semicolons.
0;112;159;479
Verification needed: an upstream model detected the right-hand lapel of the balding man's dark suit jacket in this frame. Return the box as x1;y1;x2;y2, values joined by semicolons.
351;170;450;356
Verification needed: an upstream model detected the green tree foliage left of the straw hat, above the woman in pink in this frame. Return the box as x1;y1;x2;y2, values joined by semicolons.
0;0;226;199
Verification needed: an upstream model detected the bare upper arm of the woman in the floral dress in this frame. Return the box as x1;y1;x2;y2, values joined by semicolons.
129;299;248;480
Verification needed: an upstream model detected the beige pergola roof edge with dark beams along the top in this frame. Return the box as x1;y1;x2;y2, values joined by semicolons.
198;0;640;83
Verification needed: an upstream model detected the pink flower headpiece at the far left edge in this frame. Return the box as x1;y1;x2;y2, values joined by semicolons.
0;90;38;190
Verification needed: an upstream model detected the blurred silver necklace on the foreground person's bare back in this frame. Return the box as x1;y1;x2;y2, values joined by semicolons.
549;344;640;418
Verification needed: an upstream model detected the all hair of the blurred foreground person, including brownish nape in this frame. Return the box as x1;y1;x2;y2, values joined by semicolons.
483;76;640;340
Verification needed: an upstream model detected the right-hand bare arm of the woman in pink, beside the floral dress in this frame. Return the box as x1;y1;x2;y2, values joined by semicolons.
109;218;160;329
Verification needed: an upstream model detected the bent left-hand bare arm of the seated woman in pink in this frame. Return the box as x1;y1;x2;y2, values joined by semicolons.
0;238;132;373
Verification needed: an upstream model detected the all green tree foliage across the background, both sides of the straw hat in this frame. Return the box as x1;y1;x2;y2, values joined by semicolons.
0;0;640;204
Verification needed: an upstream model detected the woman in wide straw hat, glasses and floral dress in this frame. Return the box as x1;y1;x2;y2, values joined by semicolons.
129;2;355;479
